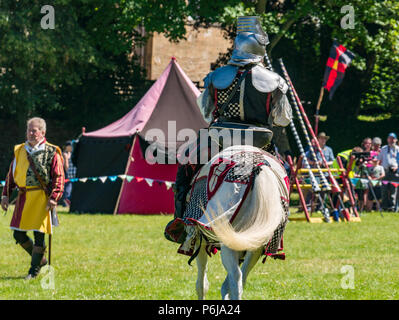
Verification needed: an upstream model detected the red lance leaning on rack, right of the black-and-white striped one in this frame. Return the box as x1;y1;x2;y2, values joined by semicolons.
279;59;341;193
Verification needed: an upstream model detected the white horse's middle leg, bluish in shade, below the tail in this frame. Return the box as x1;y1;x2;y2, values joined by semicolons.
220;246;242;300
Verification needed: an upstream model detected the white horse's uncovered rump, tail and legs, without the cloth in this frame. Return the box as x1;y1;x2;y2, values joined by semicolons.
186;146;289;300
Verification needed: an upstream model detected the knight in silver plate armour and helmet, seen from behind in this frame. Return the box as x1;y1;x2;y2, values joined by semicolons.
165;16;292;242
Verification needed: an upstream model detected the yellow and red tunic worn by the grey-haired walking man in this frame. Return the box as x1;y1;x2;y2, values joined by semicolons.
3;140;65;234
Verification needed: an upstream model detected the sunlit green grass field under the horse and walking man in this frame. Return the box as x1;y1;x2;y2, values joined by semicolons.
0;208;399;300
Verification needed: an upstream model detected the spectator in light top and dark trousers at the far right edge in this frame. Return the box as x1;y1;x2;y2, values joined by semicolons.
378;132;399;211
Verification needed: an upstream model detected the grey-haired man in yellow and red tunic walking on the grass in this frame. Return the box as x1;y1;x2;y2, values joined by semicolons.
1;118;64;279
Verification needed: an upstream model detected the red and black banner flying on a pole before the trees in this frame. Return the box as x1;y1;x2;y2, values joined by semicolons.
323;40;355;100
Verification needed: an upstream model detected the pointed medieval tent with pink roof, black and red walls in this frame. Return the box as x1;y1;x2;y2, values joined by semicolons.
70;58;207;214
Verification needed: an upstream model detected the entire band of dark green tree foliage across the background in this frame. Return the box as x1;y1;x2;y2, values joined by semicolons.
0;0;399;160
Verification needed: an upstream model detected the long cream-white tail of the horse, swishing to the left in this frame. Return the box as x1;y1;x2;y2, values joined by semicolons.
205;167;284;251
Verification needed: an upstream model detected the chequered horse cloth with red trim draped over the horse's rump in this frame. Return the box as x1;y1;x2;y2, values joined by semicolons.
178;146;289;259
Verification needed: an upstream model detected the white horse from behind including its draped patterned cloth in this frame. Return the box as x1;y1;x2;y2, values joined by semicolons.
183;145;289;300
